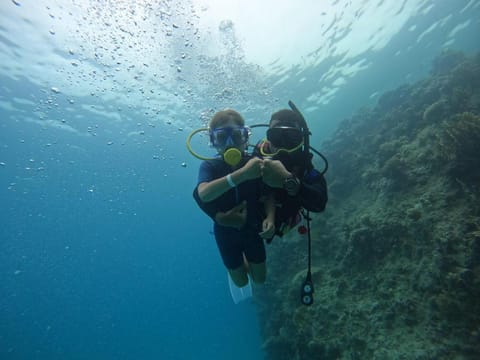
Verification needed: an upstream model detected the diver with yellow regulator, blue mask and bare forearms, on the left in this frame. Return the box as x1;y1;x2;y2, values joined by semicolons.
187;110;275;302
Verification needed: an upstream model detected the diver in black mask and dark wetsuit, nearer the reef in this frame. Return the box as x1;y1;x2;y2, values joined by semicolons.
254;104;328;242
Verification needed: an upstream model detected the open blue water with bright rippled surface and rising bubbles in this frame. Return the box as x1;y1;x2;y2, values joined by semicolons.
0;0;480;360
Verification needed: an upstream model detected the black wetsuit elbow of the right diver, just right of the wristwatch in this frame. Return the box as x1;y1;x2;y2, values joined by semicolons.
299;169;328;212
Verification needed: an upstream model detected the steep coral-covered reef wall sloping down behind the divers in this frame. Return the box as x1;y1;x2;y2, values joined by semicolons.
256;53;480;360
